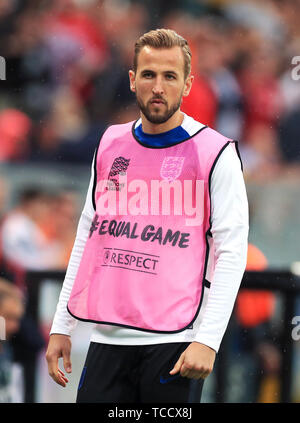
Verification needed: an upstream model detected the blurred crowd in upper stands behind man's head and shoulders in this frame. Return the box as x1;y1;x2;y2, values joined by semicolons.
0;0;300;180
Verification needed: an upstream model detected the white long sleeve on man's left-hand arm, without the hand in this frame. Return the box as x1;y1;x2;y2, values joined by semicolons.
50;158;95;335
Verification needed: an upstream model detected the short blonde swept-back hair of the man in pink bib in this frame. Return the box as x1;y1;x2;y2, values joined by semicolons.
133;28;192;79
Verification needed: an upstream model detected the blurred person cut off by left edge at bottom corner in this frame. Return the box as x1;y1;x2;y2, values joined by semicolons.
0;278;24;403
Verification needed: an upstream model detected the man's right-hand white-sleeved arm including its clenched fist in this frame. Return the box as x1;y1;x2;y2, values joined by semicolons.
170;145;249;379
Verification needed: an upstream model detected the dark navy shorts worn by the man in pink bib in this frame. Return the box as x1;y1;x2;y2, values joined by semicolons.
76;342;204;403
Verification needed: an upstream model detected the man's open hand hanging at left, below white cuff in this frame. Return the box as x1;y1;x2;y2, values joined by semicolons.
46;334;72;387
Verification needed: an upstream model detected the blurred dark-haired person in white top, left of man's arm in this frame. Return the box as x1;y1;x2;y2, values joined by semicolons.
1;187;75;402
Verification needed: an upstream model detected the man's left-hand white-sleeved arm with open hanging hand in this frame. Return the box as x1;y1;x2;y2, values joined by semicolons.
46;157;95;387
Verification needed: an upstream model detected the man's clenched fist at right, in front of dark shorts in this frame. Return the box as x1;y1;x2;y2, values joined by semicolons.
169;342;216;379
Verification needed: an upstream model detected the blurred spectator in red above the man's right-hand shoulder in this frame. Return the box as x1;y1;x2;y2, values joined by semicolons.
234;37;284;176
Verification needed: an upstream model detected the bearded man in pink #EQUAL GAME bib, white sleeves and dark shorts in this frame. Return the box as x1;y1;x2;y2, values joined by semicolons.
46;29;248;402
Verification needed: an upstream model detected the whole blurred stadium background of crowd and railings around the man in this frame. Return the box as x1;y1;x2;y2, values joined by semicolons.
0;0;300;402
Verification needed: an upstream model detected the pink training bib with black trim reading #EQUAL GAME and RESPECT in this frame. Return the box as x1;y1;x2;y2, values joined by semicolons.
68;122;236;333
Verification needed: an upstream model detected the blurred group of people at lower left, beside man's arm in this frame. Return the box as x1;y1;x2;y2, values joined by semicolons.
0;184;79;403
